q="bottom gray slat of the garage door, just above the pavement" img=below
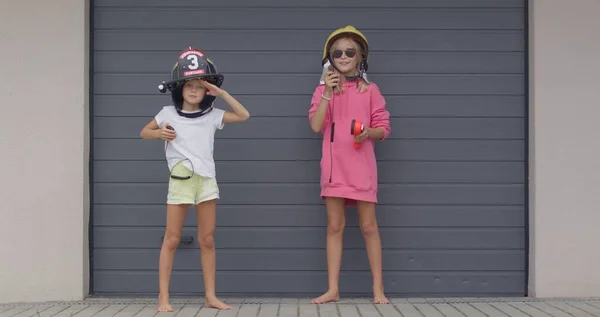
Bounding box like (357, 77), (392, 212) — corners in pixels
(93, 271), (525, 297)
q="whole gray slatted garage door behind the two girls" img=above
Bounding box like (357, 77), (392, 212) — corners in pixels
(92, 0), (526, 296)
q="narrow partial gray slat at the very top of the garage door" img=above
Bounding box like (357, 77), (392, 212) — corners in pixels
(94, 0), (523, 9)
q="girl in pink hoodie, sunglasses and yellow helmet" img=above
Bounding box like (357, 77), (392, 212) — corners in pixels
(309, 26), (391, 304)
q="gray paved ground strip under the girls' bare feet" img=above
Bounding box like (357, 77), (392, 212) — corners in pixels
(0, 298), (600, 317)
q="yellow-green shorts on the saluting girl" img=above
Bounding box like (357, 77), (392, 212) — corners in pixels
(167, 164), (219, 205)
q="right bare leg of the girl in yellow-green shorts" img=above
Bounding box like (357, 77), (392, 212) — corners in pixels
(196, 199), (231, 310)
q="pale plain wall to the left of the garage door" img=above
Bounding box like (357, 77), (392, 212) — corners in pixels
(0, 0), (89, 302)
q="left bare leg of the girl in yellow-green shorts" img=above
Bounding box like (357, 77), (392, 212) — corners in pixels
(158, 205), (190, 312)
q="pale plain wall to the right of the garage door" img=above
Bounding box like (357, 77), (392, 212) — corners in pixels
(530, 0), (600, 297)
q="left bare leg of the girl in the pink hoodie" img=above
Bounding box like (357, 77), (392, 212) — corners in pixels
(312, 197), (346, 304)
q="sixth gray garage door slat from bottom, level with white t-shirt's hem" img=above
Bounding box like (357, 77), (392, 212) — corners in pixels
(94, 161), (525, 184)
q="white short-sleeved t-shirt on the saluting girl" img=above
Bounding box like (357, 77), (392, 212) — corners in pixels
(155, 106), (225, 177)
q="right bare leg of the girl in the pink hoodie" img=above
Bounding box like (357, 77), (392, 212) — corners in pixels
(358, 201), (389, 304)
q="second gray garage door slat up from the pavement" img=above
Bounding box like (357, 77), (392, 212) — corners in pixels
(94, 248), (525, 272)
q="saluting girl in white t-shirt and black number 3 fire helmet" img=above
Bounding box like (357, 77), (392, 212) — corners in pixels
(141, 48), (250, 312)
